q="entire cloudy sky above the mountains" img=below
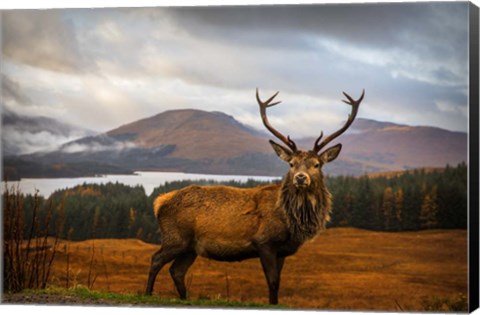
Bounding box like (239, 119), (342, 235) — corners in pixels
(1, 2), (469, 151)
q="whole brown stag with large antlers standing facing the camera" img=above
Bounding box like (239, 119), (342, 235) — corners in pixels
(145, 88), (365, 304)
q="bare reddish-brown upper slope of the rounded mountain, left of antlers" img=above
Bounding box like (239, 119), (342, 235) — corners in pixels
(107, 109), (271, 160)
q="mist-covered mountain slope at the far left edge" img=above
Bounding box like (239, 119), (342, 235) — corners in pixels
(2, 108), (95, 156)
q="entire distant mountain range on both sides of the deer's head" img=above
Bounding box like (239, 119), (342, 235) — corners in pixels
(4, 109), (467, 179)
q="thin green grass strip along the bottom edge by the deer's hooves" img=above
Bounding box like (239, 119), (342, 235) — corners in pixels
(19, 286), (288, 309)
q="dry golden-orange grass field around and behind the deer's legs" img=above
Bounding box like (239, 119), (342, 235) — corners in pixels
(47, 228), (468, 311)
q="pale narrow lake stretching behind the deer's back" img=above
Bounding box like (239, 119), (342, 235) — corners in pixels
(2, 172), (279, 197)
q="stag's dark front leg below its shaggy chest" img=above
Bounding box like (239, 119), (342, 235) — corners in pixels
(259, 248), (283, 304)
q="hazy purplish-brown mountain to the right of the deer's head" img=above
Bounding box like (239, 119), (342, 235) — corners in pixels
(302, 118), (468, 173)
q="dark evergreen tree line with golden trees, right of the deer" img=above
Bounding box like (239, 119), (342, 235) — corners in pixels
(328, 163), (468, 231)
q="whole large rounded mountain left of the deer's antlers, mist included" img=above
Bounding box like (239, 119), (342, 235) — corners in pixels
(53, 109), (281, 175)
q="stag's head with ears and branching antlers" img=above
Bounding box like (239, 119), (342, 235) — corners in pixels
(256, 89), (365, 190)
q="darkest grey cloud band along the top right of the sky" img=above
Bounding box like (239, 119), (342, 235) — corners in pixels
(169, 3), (468, 78)
